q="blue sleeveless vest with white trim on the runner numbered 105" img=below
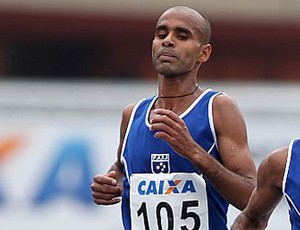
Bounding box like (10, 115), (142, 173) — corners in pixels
(122, 89), (228, 230)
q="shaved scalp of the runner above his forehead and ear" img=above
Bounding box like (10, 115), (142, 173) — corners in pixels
(157, 6), (211, 44)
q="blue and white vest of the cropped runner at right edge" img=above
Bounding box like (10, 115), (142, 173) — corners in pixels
(282, 139), (300, 230)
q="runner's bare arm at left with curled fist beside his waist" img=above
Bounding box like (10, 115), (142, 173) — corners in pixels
(91, 105), (134, 205)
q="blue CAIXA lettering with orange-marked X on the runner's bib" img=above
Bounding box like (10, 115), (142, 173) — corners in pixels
(138, 180), (196, 196)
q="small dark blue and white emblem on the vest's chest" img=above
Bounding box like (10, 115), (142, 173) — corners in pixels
(151, 153), (170, 173)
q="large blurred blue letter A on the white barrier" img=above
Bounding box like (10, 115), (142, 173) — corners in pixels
(34, 138), (93, 205)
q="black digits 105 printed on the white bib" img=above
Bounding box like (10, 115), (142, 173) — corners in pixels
(137, 200), (201, 230)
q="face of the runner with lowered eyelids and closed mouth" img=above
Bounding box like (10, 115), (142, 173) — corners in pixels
(152, 11), (202, 77)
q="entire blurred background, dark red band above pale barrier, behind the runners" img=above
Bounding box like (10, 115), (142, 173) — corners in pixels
(0, 0), (300, 230)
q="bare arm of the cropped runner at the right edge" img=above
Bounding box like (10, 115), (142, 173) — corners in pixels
(231, 148), (288, 230)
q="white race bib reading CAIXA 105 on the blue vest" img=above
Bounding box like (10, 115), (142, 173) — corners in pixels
(130, 173), (209, 230)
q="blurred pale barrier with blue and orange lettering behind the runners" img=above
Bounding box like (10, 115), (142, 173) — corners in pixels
(0, 81), (300, 230)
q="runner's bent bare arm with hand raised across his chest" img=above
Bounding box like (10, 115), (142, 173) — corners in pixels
(151, 95), (256, 209)
